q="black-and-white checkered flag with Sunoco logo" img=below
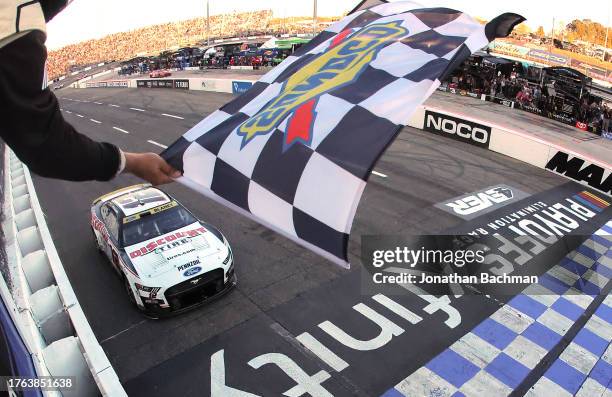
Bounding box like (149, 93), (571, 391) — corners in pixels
(162, 1), (523, 267)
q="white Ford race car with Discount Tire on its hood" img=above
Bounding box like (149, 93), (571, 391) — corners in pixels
(91, 184), (236, 318)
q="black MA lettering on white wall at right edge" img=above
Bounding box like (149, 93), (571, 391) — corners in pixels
(546, 151), (612, 195)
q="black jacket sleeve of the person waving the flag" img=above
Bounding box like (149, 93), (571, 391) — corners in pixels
(0, 31), (120, 181)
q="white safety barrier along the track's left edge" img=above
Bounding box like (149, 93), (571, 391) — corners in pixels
(0, 147), (127, 397)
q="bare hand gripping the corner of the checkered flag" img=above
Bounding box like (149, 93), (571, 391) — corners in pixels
(124, 152), (181, 186)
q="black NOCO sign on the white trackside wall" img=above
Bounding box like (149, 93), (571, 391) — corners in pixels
(424, 110), (491, 149)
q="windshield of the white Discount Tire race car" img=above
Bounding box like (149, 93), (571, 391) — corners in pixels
(122, 205), (197, 247)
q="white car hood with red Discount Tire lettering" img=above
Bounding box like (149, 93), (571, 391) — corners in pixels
(125, 222), (229, 280)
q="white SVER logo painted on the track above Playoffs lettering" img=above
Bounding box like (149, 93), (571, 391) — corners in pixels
(436, 185), (529, 219)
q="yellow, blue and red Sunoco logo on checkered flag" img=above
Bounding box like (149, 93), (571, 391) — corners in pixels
(237, 21), (408, 150)
